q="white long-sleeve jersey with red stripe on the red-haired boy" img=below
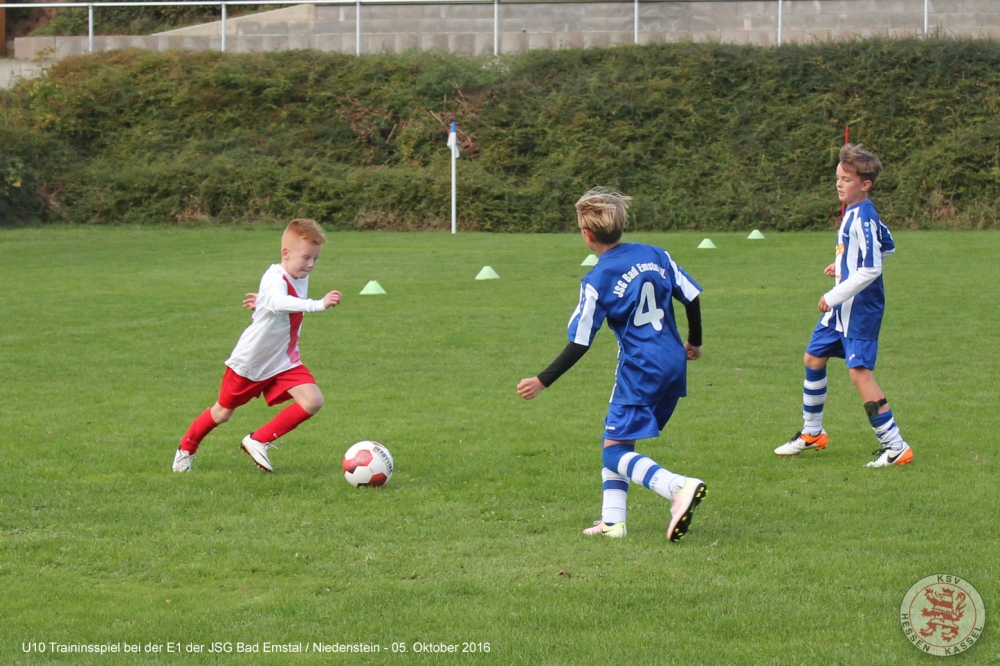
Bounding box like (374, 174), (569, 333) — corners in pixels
(226, 264), (326, 382)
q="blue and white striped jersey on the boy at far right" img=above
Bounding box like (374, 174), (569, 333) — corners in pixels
(820, 199), (896, 340)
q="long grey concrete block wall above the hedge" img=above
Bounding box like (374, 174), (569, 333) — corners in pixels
(9, 0), (1000, 74)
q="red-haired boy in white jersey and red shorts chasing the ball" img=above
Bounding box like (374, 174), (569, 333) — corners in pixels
(173, 220), (340, 472)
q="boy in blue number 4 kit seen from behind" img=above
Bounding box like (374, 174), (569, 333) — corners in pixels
(517, 189), (706, 541)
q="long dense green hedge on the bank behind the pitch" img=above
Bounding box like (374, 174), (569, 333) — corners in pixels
(0, 39), (1000, 231)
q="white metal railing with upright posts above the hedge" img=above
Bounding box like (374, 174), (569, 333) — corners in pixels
(0, 0), (930, 55)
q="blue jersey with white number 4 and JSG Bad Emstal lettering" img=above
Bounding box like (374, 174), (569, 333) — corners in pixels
(569, 243), (701, 405)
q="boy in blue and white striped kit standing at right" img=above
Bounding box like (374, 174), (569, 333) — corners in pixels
(774, 144), (913, 467)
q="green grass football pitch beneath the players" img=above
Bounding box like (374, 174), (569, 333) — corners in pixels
(0, 228), (1000, 664)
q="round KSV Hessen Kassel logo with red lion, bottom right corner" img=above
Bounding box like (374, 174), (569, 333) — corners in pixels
(899, 574), (986, 657)
